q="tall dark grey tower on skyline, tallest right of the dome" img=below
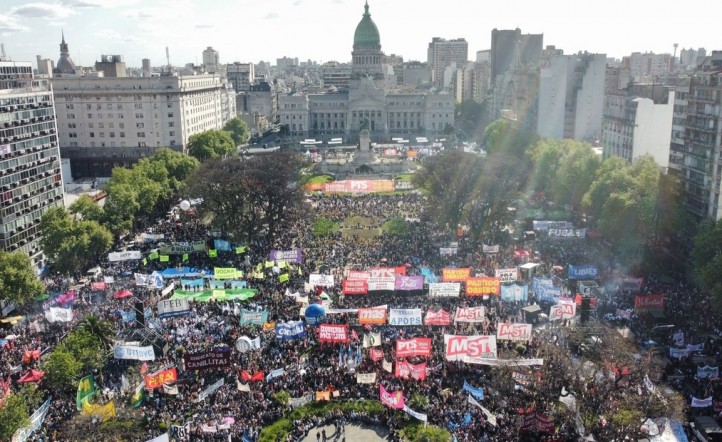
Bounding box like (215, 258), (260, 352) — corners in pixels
(491, 28), (544, 85)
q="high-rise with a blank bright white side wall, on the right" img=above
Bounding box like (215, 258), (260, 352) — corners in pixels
(602, 84), (675, 167)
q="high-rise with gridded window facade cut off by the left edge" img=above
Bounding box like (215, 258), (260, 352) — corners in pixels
(0, 61), (63, 267)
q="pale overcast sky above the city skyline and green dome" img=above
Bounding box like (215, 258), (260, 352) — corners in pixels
(0, 0), (722, 66)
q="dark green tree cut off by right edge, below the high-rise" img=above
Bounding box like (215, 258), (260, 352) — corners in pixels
(691, 220), (722, 310)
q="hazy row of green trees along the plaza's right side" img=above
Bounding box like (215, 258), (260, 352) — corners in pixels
(414, 120), (687, 263)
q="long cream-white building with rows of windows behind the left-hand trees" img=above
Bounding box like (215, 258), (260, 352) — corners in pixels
(51, 74), (236, 177)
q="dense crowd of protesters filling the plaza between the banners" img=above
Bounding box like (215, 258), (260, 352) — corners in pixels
(0, 195), (722, 442)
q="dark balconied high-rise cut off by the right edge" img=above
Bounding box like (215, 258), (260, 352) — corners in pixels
(679, 51), (722, 220)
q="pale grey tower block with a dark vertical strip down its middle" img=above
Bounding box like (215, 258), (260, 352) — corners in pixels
(537, 53), (606, 140)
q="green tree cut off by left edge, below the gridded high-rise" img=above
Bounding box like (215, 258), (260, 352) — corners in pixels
(0, 250), (45, 305)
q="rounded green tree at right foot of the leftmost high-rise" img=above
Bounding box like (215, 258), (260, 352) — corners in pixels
(40, 207), (113, 274)
